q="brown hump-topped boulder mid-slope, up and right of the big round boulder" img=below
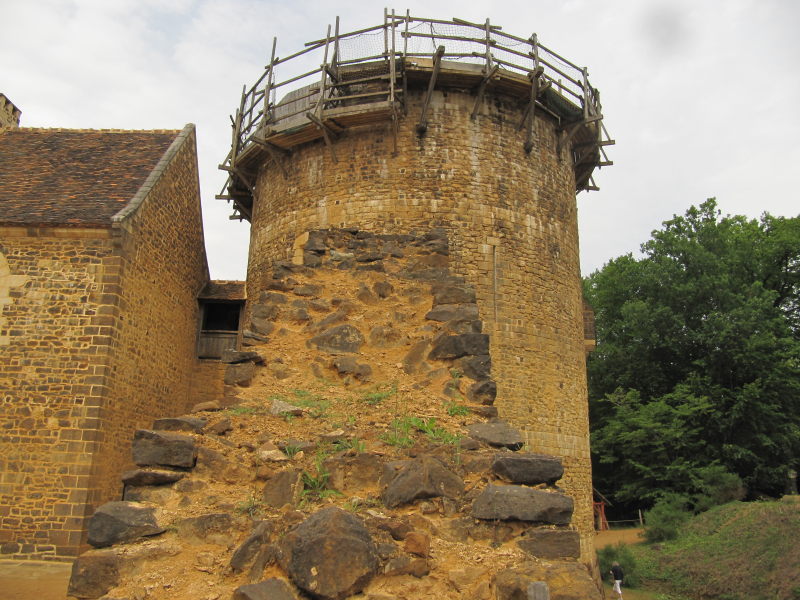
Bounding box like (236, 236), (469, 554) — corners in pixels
(382, 456), (464, 508)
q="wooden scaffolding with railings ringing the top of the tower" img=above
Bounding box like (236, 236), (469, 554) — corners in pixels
(217, 10), (614, 220)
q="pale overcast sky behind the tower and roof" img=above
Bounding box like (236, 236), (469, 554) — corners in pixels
(0, 0), (800, 279)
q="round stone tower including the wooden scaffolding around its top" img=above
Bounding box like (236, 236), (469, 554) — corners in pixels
(221, 14), (612, 558)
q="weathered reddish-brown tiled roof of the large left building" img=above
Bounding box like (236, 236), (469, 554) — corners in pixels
(0, 128), (180, 227)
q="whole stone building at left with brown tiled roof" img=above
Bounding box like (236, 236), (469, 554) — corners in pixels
(0, 119), (212, 558)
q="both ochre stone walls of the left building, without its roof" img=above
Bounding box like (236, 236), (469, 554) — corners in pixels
(0, 127), (208, 559)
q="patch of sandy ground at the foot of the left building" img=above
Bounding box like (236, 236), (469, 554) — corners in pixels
(0, 561), (72, 600)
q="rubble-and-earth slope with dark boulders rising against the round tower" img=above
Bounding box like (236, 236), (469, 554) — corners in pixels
(70, 230), (599, 600)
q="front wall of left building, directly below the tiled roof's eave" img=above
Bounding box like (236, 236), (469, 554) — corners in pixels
(0, 228), (116, 559)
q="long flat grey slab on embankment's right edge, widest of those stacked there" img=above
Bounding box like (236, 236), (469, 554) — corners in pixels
(472, 484), (573, 525)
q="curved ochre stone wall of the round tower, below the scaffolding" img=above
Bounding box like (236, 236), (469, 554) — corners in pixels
(248, 91), (593, 560)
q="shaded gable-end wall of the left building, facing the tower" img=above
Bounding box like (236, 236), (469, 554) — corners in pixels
(87, 127), (209, 536)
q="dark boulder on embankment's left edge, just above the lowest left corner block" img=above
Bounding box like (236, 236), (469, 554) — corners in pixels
(87, 501), (166, 548)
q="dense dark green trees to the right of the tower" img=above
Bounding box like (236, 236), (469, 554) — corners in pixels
(584, 199), (800, 503)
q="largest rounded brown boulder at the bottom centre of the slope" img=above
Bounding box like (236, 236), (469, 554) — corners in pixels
(284, 506), (378, 600)
